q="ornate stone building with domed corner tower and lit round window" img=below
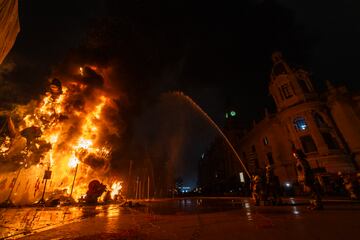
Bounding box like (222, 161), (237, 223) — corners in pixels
(199, 52), (360, 193)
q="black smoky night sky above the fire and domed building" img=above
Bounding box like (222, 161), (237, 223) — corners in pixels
(0, 0), (360, 188)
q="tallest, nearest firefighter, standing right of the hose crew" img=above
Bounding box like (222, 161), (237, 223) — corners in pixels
(293, 149), (323, 210)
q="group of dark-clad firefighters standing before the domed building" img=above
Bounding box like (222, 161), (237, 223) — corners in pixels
(251, 149), (360, 210)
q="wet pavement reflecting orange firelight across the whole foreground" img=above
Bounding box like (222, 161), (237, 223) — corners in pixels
(0, 198), (360, 240)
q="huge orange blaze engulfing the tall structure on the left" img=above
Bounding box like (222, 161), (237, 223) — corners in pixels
(0, 68), (121, 204)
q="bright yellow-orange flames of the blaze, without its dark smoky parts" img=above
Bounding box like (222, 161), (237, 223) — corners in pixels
(0, 64), (122, 202)
